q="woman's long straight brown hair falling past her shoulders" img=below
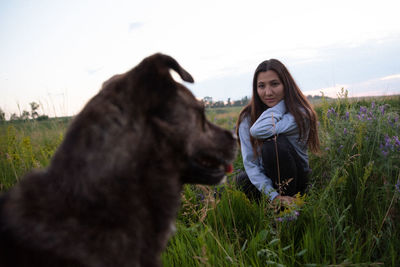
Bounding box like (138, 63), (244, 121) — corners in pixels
(236, 59), (319, 155)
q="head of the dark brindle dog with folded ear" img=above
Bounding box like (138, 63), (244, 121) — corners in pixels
(103, 54), (236, 184)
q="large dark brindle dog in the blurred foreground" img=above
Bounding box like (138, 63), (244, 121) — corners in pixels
(0, 53), (236, 267)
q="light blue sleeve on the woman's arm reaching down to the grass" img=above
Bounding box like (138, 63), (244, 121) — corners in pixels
(239, 117), (279, 201)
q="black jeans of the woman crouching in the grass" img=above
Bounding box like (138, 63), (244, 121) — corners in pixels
(236, 135), (309, 200)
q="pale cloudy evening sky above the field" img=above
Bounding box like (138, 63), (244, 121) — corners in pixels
(0, 0), (400, 117)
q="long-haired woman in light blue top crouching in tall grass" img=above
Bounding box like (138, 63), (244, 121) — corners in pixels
(236, 59), (319, 204)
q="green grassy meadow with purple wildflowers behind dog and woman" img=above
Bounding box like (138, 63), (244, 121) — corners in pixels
(0, 92), (400, 267)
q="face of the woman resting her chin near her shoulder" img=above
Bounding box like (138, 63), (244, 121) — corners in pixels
(257, 70), (285, 108)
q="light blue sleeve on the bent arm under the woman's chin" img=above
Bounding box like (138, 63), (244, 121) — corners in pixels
(250, 100), (298, 139)
